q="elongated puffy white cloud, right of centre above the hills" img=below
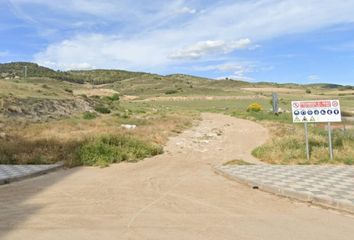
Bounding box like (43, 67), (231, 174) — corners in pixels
(170, 38), (251, 59)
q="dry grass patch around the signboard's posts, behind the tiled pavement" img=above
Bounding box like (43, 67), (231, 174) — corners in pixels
(252, 123), (354, 165)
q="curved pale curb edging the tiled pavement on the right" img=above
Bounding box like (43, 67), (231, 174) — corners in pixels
(213, 166), (354, 214)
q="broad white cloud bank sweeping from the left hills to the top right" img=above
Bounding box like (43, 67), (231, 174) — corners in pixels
(18, 0), (354, 71)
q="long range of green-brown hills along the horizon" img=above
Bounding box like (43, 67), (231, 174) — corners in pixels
(0, 62), (353, 90)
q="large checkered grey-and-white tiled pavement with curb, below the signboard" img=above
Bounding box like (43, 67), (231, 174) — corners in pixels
(217, 165), (354, 213)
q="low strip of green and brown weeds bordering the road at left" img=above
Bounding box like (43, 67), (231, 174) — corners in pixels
(0, 135), (162, 167)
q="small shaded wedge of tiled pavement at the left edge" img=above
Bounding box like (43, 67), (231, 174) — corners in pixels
(0, 163), (63, 185)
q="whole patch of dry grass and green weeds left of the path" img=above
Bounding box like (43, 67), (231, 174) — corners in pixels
(0, 113), (195, 166)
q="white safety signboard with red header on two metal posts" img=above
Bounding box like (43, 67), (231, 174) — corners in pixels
(291, 100), (342, 160)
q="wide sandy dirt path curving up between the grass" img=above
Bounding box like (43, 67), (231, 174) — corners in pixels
(0, 114), (354, 240)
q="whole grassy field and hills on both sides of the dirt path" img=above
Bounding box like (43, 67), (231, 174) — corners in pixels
(0, 62), (354, 166)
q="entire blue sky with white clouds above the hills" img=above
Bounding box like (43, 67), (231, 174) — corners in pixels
(0, 0), (354, 85)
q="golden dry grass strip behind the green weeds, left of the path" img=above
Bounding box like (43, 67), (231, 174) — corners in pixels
(11, 111), (195, 144)
